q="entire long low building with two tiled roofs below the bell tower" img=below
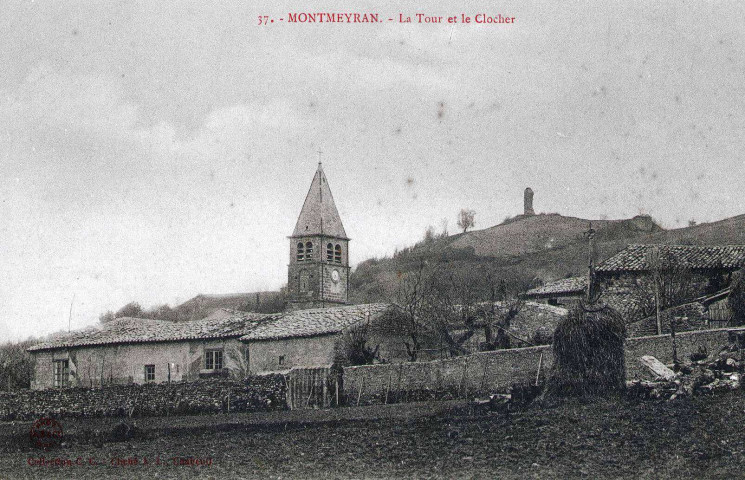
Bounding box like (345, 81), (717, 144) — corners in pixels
(29, 304), (407, 390)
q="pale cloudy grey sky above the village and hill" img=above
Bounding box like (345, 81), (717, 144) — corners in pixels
(0, 0), (745, 339)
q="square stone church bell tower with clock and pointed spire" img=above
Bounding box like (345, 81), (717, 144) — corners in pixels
(287, 162), (349, 310)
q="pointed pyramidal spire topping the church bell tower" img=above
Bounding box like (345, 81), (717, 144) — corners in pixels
(292, 161), (347, 239)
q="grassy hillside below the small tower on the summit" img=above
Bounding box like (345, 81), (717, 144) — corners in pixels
(351, 214), (745, 302)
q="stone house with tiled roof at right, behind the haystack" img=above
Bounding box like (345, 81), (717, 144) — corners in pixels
(595, 245), (745, 323)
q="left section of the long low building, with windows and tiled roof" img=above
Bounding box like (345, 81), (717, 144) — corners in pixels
(28, 310), (272, 390)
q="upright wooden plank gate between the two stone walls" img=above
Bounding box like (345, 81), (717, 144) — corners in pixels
(285, 366), (341, 410)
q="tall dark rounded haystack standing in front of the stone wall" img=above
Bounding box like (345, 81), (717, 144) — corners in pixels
(545, 304), (626, 396)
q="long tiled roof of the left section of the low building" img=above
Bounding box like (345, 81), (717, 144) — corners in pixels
(28, 309), (272, 351)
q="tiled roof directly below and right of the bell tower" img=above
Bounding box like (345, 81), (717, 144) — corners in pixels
(241, 303), (392, 341)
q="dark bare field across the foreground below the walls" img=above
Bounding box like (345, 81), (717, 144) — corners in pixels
(0, 392), (745, 479)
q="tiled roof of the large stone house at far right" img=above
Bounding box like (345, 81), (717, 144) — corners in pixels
(596, 245), (745, 273)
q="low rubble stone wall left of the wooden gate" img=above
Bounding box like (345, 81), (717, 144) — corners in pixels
(0, 375), (286, 420)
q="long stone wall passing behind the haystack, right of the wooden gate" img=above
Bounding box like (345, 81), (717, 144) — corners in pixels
(344, 329), (745, 404)
